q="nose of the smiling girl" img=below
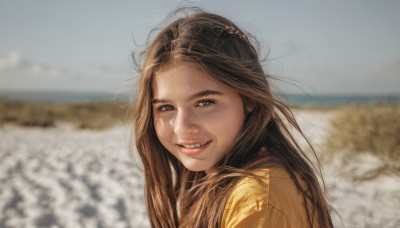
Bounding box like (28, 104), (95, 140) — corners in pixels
(172, 110), (199, 136)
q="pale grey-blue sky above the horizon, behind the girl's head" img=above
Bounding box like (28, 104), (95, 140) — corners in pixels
(0, 0), (400, 95)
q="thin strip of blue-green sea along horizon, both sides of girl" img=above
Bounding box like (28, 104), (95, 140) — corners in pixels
(0, 91), (400, 106)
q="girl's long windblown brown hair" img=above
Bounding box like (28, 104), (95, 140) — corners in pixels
(134, 9), (332, 227)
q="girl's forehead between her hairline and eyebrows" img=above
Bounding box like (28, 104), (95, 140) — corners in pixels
(153, 63), (228, 98)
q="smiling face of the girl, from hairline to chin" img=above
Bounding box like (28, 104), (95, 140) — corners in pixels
(153, 63), (245, 172)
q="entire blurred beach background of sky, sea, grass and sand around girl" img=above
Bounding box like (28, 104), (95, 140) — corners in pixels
(0, 0), (400, 227)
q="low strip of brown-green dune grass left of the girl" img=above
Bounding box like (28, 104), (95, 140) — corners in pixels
(0, 100), (133, 130)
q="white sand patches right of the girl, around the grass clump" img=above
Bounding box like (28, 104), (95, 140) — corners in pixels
(297, 111), (400, 228)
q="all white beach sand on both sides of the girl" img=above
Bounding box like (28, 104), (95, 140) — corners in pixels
(0, 111), (400, 228)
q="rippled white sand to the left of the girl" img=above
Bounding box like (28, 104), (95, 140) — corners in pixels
(0, 124), (148, 227)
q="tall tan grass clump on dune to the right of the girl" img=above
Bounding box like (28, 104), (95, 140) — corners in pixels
(326, 103), (400, 174)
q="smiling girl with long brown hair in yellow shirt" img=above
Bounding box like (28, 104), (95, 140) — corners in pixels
(134, 10), (332, 227)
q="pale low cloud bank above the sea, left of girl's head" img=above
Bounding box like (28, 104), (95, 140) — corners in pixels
(0, 52), (128, 92)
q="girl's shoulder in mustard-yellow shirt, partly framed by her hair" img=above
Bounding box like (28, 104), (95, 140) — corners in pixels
(222, 167), (306, 227)
